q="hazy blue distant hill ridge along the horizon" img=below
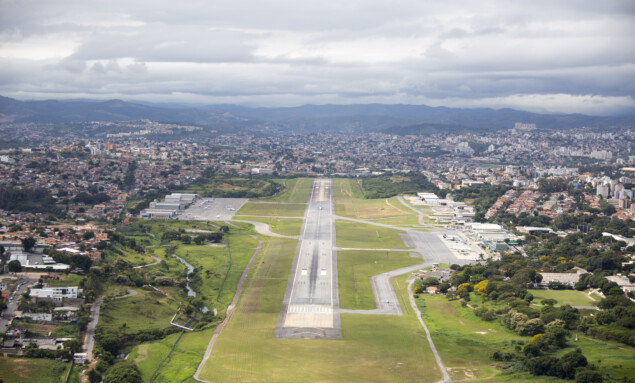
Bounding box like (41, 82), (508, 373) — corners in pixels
(0, 96), (635, 134)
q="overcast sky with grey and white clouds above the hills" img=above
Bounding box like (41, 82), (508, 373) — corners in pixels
(0, 0), (635, 115)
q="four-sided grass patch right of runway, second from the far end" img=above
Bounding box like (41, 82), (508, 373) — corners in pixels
(335, 220), (408, 249)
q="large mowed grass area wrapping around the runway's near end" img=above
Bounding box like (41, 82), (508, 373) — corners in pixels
(200, 238), (441, 383)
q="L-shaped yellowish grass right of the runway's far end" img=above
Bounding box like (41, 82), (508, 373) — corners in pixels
(333, 178), (416, 219)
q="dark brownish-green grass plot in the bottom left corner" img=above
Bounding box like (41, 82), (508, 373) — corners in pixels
(0, 356), (69, 383)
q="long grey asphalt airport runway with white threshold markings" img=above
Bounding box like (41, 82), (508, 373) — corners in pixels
(275, 178), (341, 339)
